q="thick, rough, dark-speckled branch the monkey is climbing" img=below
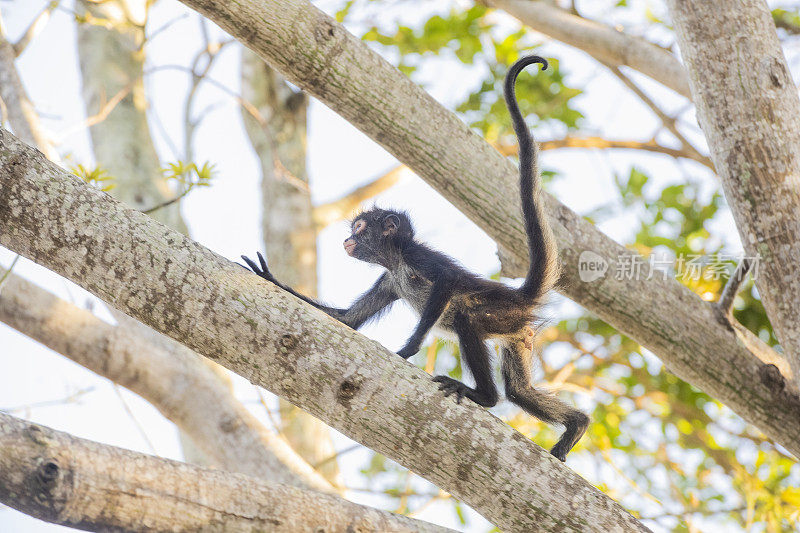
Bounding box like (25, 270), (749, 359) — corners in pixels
(0, 130), (646, 531)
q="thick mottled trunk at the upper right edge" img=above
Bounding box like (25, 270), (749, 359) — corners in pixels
(668, 0), (800, 379)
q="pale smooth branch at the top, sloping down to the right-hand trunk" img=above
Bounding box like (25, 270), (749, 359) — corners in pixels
(481, 0), (692, 98)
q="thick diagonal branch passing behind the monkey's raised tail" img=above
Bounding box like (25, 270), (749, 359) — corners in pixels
(173, 0), (800, 456)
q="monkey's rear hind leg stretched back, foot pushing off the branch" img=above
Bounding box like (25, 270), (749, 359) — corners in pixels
(502, 342), (589, 462)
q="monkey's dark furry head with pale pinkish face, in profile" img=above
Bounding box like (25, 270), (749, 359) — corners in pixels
(344, 207), (414, 266)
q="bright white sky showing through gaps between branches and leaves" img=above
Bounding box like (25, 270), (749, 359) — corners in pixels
(0, 0), (788, 531)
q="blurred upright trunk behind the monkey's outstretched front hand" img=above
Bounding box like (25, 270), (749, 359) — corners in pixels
(242, 48), (339, 484)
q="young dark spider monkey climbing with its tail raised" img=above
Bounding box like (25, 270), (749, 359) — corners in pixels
(247, 56), (589, 461)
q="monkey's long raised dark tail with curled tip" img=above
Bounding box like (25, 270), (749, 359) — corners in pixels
(505, 56), (558, 300)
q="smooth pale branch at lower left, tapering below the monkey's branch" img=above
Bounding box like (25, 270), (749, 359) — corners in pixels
(0, 274), (334, 492)
